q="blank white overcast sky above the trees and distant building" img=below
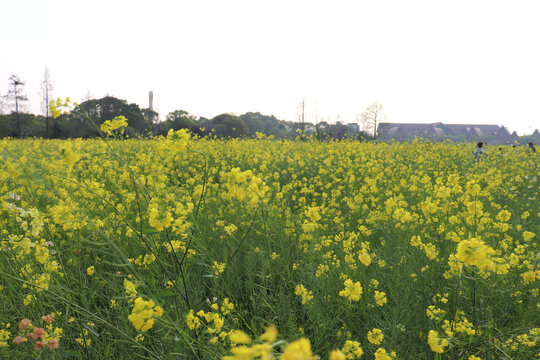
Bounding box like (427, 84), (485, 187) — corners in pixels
(0, 0), (540, 134)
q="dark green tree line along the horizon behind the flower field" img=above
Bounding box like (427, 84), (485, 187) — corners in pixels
(0, 69), (376, 140)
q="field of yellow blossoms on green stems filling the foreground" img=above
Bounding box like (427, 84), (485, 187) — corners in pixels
(0, 129), (540, 360)
